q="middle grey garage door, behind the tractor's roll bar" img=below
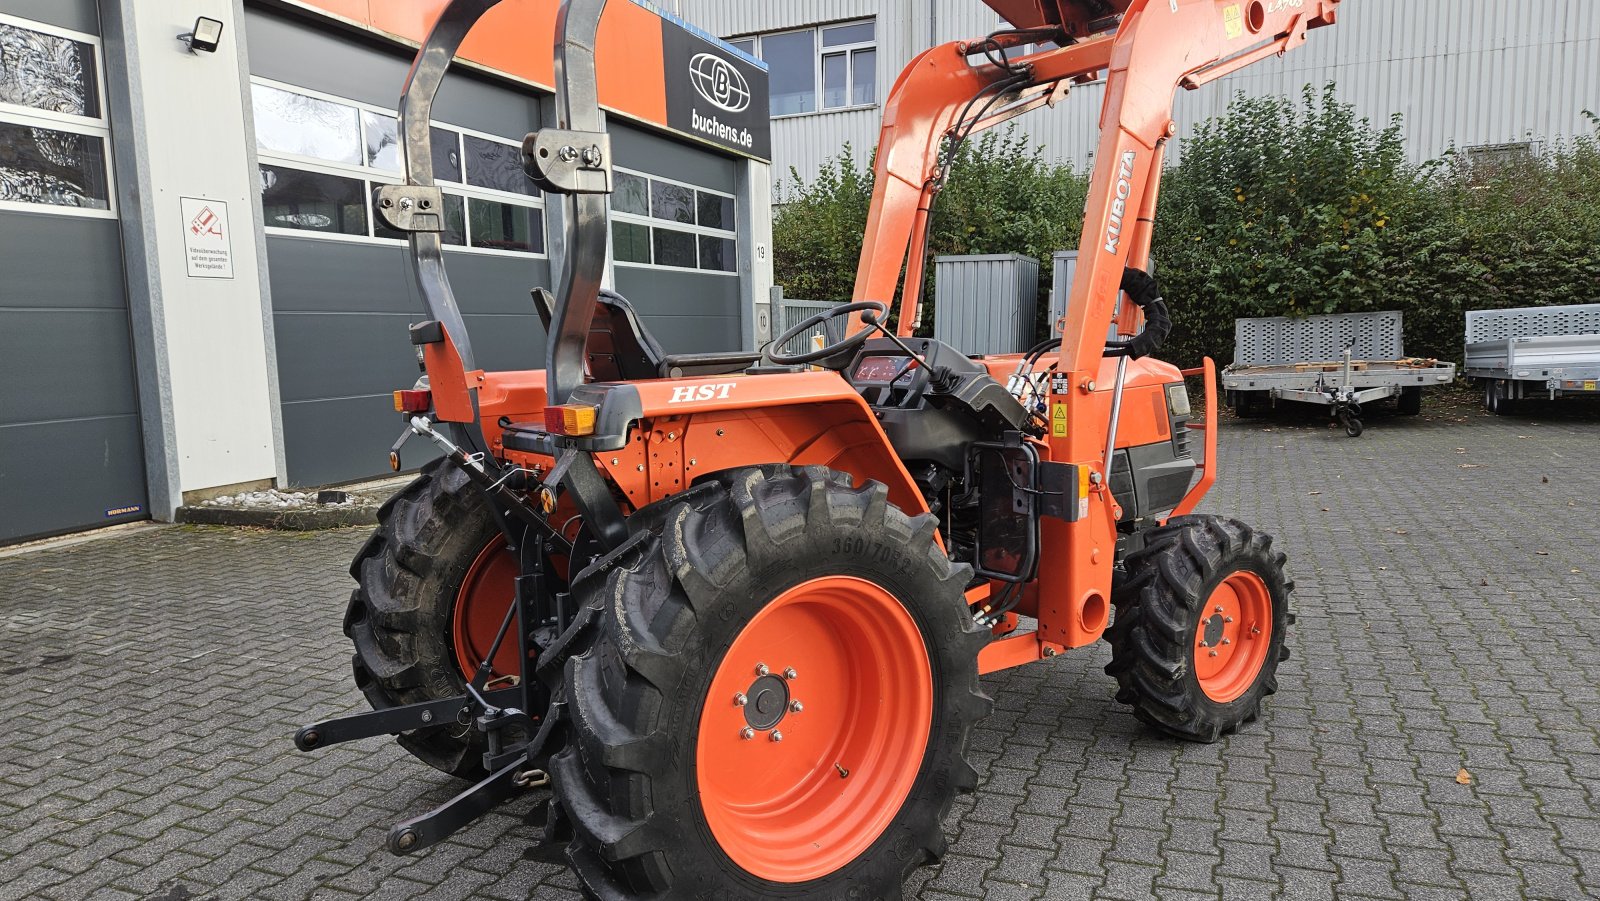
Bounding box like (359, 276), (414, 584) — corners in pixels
(246, 11), (550, 485)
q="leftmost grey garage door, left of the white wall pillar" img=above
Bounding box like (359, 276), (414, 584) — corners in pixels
(0, 0), (147, 543)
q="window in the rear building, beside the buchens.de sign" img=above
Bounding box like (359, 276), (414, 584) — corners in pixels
(728, 19), (878, 115)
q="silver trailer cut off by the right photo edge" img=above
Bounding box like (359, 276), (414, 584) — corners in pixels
(1462, 304), (1600, 414)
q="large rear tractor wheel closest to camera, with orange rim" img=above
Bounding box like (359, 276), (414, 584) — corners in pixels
(550, 467), (990, 898)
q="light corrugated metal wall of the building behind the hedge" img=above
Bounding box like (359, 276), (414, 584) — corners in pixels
(672, 0), (1600, 184)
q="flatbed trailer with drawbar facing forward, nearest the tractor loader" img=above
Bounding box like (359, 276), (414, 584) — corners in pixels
(1222, 310), (1456, 437)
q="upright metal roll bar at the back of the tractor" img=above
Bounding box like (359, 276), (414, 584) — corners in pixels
(378, 0), (611, 408)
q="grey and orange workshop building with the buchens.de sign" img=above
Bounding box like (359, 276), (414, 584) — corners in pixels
(0, 0), (771, 543)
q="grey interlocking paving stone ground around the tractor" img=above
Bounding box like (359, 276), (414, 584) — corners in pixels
(0, 396), (1600, 901)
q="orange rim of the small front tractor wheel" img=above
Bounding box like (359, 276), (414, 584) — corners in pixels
(1195, 570), (1272, 704)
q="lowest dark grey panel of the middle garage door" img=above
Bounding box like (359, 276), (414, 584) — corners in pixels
(283, 392), (438, 485)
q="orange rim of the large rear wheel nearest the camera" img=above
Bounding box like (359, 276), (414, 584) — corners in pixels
(694, 576), (933, 882)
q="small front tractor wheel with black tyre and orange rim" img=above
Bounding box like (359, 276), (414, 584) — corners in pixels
(1106, 515), (1294, 743)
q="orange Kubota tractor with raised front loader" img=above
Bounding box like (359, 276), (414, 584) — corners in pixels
(296, 0), (1339, 898)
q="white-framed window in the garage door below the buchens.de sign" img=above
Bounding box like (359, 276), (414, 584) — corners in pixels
(611, 170), (739, 272)
